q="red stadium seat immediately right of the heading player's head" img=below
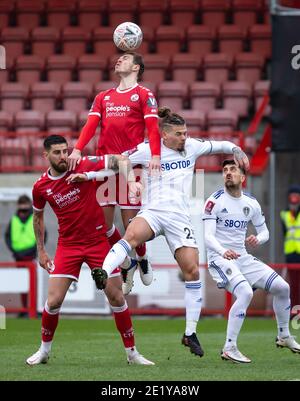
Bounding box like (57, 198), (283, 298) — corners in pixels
(139, 54), (170, 84)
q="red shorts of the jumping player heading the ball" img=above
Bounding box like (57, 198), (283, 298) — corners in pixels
(96, 166), (141, 210)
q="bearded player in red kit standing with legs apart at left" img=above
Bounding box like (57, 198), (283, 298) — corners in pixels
(26, 135), (154, 365)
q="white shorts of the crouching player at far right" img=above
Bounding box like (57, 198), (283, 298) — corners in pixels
(208, 253), (278, 292)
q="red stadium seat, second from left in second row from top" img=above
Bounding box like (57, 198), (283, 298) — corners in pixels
(31, 27), (60, 57)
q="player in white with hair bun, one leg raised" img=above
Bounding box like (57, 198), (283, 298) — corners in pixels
(68, 109), (249, 357)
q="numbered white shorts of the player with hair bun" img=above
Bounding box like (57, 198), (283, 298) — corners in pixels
(136, 210), (198, 255)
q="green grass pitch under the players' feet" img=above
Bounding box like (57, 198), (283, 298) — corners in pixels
(0, 318), (300, 382)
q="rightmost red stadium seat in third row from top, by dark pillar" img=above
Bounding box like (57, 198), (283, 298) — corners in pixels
(235, 53), (264, 85)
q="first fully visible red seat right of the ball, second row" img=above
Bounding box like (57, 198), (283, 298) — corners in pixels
(156, 25), (184, 56)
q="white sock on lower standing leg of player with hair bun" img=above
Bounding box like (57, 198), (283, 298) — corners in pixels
(184, 280), (202, 336)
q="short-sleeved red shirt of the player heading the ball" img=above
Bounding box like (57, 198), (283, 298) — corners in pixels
(89, 84), (158, 155)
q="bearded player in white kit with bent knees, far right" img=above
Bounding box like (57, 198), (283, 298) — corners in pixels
(203, 160), (300, 363)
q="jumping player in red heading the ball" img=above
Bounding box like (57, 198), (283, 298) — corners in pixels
(69, 52), (160, 285)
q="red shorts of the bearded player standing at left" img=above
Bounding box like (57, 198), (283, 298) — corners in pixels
(50, 237), (120, 281)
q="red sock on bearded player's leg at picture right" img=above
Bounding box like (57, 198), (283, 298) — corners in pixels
(112, 303), (135, 348)
